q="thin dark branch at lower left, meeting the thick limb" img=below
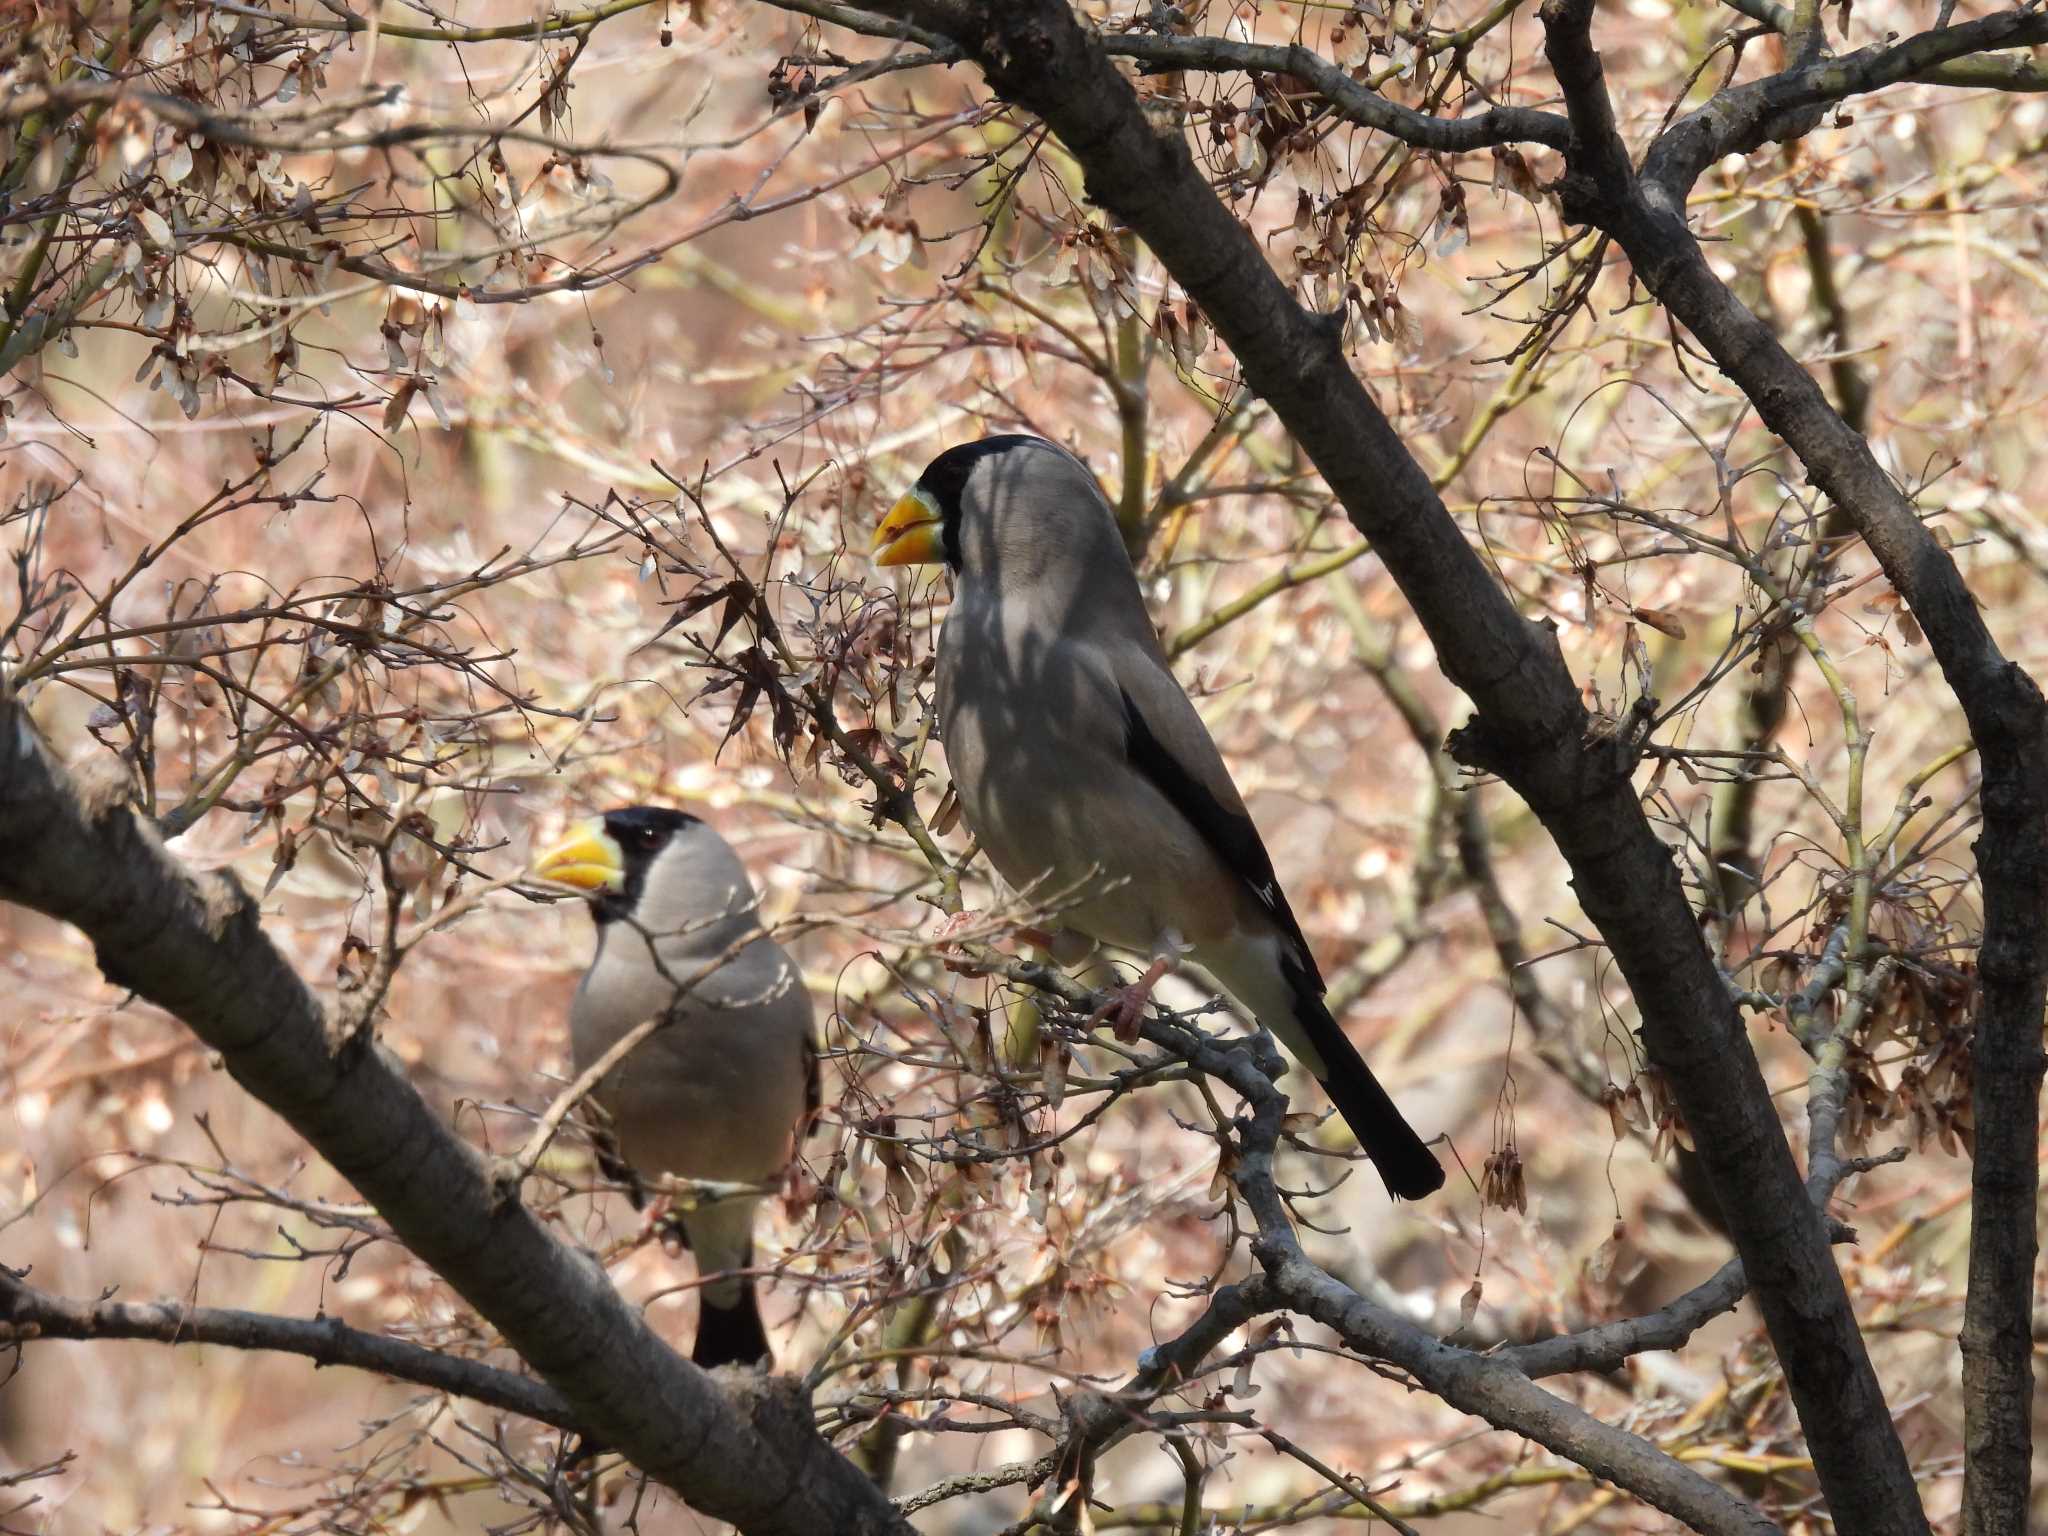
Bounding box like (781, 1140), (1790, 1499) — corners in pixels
(0, 1266), (584, 1430)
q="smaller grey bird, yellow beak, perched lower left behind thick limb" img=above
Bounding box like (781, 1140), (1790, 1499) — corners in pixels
(532, 805), (817, 1370)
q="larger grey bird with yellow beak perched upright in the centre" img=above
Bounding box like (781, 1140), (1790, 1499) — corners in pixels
(870, 434), (1444, 1200)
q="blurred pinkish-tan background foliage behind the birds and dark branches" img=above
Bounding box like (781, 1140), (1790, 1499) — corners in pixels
(0, 0), (2048, 1534)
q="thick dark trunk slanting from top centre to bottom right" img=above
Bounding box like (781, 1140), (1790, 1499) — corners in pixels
(864, 0), (1927, 1536)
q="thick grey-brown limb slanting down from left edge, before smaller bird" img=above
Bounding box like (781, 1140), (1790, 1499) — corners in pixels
(0, 690), (909, 1536)
